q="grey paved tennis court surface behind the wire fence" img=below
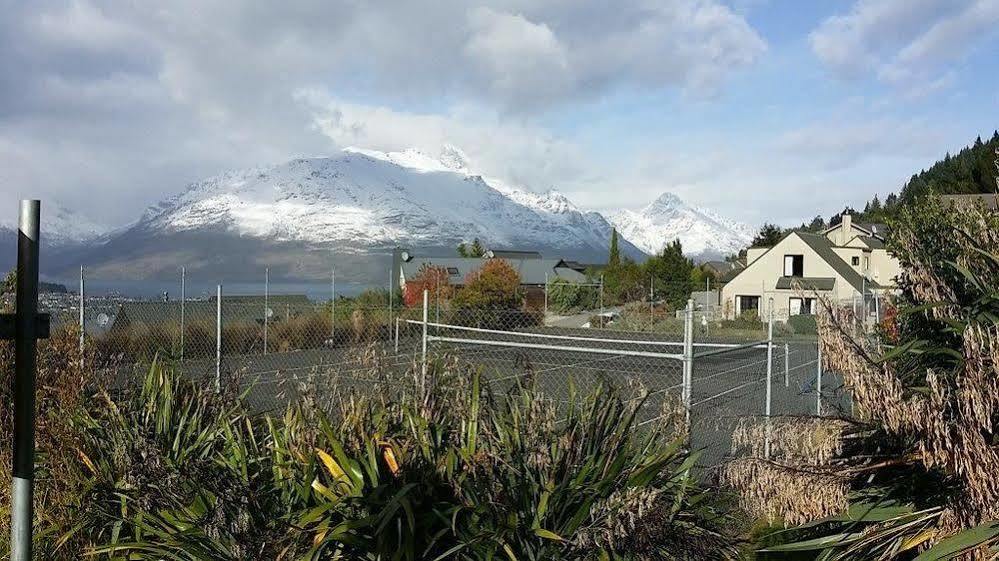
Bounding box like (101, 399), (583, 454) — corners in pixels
(103, 327), (845, 466)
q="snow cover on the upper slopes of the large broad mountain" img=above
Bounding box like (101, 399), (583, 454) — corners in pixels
(129, 146), (640, 255)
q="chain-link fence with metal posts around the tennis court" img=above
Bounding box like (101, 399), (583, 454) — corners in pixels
(41, 274), (848, 465)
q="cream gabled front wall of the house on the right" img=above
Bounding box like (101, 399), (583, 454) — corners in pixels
(721, 235), (854, 319)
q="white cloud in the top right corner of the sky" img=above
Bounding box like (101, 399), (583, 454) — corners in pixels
(809, 0), (999, 92)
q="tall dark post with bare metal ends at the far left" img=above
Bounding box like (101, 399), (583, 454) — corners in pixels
(10, 200), (41, 561)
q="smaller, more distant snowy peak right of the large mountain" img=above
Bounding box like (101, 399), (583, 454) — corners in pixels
(610, 193), (754, 259)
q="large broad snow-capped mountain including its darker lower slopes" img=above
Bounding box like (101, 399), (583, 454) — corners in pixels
(76, 146), (643, 280)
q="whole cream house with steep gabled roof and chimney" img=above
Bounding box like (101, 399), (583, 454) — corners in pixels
(721, 215), (899, 319)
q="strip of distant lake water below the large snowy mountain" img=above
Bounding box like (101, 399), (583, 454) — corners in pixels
(42, 278), (384, 301)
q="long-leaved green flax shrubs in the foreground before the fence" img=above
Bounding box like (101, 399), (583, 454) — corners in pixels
(7, 340), (734, 560)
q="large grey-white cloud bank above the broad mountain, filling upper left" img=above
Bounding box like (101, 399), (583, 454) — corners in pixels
(0, 0), (766, 223)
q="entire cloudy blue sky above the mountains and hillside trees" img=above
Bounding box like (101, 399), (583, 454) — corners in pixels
(0, 0), (999, 229)
